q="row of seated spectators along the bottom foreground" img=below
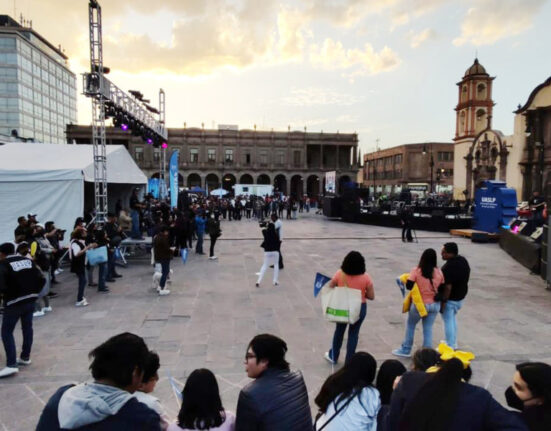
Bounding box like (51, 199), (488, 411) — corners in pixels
(28, 333), (551, 431)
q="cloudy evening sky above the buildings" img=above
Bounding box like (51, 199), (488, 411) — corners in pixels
(4, 0), (551, 153)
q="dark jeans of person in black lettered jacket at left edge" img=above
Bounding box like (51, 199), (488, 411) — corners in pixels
(2, 301), (34, 368)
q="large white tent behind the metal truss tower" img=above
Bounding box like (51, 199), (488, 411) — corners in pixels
(0, 142), (147, 242)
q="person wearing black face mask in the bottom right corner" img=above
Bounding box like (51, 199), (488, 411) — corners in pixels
(505, 362), (551, 431)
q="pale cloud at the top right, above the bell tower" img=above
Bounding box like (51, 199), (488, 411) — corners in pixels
(453, 0), (545, 46)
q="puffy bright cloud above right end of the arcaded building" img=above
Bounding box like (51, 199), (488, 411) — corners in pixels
(310, 38), (401, 76)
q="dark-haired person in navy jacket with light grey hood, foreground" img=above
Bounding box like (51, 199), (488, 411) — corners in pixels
(36, 332), (161, 431)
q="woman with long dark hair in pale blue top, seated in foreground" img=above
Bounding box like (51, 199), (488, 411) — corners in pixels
(314, 352), (381, 431)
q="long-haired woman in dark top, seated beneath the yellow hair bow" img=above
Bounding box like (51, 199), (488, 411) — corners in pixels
(389, 358), (526, 431)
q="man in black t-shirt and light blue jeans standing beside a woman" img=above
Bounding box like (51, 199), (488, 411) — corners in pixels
(440, 242), (471, 349)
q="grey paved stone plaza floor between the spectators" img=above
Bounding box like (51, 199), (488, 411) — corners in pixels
(0, 212), (551, 431)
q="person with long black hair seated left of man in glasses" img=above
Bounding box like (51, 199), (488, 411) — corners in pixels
(168, 368), (235, 431)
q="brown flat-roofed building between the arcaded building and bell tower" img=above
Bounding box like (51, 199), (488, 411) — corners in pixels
(363, 142), (454, 194)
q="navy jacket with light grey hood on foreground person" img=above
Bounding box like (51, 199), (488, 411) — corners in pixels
(36, 383), (161, 431)
